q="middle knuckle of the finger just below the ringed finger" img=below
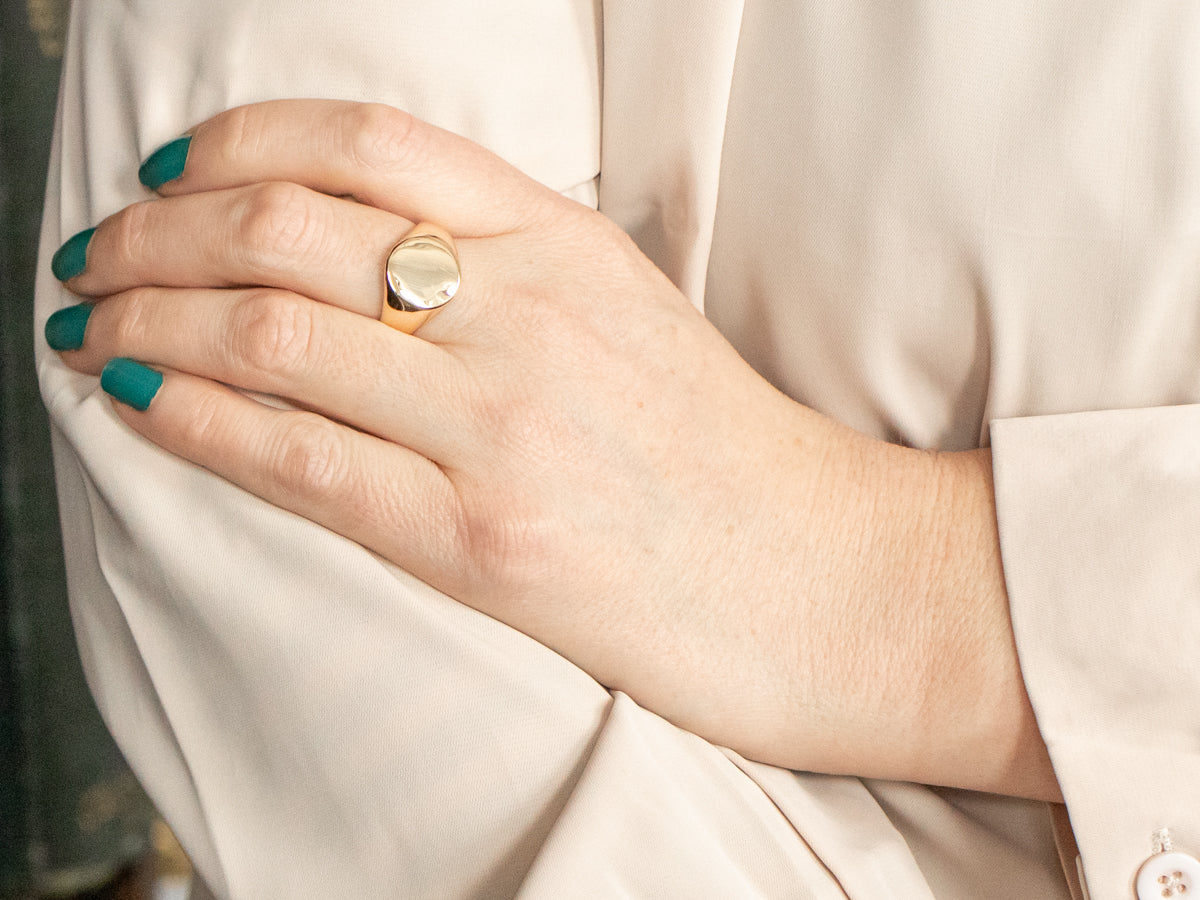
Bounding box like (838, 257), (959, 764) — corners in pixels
(229, 288), (314, 377)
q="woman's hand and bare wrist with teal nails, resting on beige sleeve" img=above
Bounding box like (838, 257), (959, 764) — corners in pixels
(50, 101), (1056, 796)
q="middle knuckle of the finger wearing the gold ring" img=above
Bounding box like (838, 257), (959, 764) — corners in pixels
(234, 181), (319, 271)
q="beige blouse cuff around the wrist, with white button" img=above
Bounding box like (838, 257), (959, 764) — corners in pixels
(991, 404), (1200, 900)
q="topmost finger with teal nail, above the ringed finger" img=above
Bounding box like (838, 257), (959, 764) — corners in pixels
(143, 100), (557, 238)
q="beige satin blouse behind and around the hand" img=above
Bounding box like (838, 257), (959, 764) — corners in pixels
(30, 0), (1200, 900)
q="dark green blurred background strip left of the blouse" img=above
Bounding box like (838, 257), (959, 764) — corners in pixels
(0, 0), (152, 898)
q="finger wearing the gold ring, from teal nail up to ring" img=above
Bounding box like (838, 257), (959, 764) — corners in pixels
(63, 181), (410, 318)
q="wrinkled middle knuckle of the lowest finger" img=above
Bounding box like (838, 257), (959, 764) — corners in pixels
(268, 413), (349, 498)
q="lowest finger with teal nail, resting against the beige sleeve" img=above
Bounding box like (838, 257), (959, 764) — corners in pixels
(102, 360), (457, 576)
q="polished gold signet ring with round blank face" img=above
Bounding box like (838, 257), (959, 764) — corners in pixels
(379, 222), (462, 335)
